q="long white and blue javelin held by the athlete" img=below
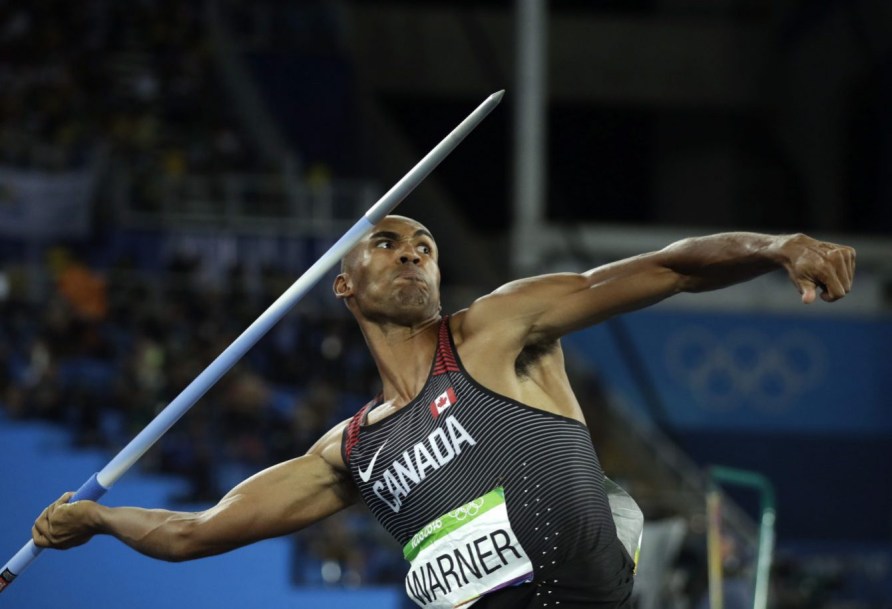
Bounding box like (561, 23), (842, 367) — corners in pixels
(0, 90), (505, 591)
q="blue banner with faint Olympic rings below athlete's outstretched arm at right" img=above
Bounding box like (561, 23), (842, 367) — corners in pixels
(564, 309), (892, 434)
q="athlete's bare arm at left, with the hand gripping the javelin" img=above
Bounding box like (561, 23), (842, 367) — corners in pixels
(32, 421), (357, 561)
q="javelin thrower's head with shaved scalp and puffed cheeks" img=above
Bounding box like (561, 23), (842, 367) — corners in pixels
(334, 216), (440, 324)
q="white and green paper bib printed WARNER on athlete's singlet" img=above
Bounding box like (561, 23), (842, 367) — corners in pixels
(403, 487), (533, 609)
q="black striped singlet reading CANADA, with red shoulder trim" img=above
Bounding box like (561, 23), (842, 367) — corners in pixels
(342, 318), (633, 609)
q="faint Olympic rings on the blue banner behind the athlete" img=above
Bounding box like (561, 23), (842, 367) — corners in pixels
(665, 326), (828, 412)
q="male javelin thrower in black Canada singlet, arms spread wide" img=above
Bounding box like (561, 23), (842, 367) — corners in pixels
(33, 216), (855, 609)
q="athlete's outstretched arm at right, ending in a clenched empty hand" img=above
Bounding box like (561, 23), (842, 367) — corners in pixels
(466, 232), (855, 344)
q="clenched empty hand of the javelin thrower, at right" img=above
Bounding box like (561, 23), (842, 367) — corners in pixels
(781, 234), (855, 304)
